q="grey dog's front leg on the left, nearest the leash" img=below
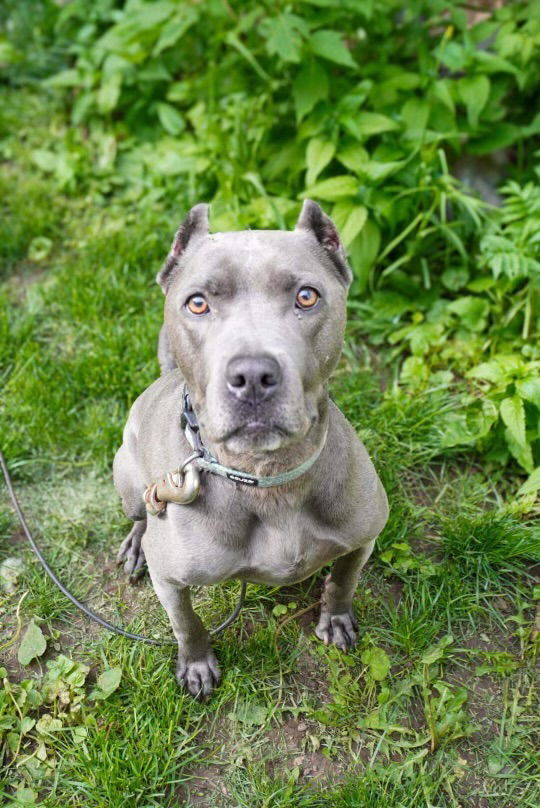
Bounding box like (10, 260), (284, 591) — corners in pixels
(152, 577), (221, 699)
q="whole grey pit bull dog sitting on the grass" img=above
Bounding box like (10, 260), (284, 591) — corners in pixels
(114, 200), (388, 697)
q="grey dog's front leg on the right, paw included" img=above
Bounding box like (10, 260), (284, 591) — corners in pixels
(315, 541), (375, 652)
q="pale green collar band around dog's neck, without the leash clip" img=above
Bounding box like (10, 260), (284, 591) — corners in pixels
(180, 388), (328, 488)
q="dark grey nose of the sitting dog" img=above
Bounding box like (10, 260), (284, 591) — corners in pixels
(225, 356), (281, 404)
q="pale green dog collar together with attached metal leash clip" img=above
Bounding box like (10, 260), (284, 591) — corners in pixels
(144, 389), (328, 515)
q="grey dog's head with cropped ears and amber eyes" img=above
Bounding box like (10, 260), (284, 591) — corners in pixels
(157, 200), (352, 453)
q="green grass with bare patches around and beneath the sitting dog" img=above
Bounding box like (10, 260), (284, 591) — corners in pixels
(0, 91), (540, 808)
